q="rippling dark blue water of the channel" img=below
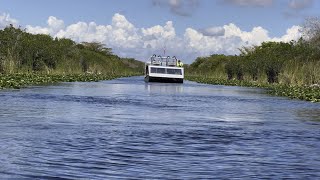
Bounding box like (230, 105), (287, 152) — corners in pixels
(0, 77), (320, 179)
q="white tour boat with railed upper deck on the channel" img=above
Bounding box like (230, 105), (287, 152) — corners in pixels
(144, 54), (184, 83)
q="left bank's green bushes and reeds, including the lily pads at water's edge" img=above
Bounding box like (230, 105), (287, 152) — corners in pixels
(0, 25), (144, 89)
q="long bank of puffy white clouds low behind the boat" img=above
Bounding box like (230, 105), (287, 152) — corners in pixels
(23, 13), (301, 63)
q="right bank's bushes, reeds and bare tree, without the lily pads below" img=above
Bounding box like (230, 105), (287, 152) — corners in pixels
(186, 18), (320, 85)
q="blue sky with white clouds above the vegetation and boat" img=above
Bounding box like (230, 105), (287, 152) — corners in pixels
(0, 0), (320, 63)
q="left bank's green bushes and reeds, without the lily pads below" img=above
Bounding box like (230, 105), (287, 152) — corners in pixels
(0, 25), (143, 74)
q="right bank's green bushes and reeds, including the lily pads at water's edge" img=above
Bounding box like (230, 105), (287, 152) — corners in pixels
(185, 18), (320, 102)
